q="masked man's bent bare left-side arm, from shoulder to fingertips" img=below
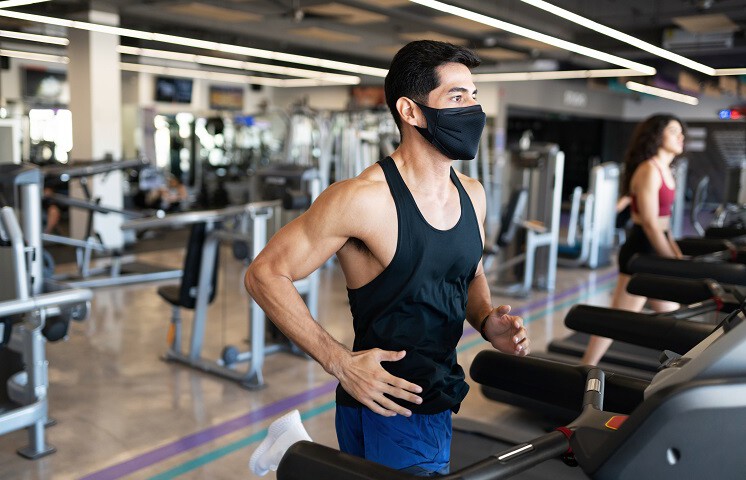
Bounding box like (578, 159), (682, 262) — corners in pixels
(244, 180), (422, 416)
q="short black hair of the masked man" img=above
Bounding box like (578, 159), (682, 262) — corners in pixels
(384, 40), (482, 130)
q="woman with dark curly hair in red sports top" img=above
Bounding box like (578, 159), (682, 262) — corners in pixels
(582, 114), (684, 365)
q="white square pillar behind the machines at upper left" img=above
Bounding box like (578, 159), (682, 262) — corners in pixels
(67, 1), (124, 248)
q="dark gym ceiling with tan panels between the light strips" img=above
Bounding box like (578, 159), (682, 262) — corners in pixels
(0, 0), (746, 83)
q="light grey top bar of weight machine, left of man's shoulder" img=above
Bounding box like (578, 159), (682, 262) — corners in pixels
(122, 200), (282, 230)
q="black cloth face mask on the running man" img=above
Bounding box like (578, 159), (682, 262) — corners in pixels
(414, 102), (487, 160)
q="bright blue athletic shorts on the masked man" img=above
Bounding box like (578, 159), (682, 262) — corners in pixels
(335, 405), (452, 476)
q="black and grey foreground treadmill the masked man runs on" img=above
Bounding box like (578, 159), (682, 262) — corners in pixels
(277, 309), (746, 480)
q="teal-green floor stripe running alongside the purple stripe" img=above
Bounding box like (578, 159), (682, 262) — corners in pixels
(154, 279), (616, 480)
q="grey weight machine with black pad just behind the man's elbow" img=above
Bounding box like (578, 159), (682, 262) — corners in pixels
(122, 169), (320, 390)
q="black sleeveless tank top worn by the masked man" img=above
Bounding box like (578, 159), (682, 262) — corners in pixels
(337, 157), (482, 414)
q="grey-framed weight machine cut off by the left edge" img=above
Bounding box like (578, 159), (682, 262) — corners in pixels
(0, 165), (93, 459)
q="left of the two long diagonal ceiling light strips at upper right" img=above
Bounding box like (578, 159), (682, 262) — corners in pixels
(410, 0), (655, 75)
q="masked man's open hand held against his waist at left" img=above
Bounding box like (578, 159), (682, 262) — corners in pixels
(336, 348), (422, 417)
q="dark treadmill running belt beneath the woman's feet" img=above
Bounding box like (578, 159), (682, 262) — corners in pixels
(547, 333), (661, 372)
